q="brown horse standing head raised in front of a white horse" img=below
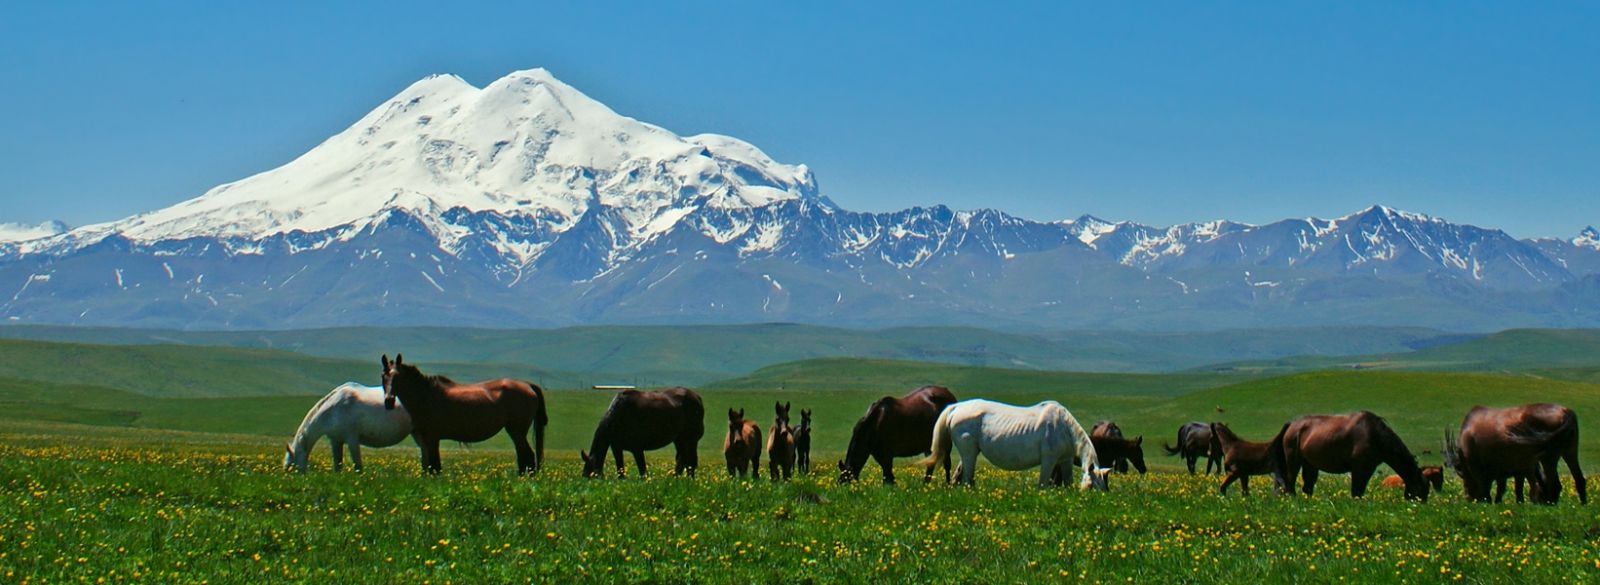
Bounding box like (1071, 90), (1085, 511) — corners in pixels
(382, 353), (550, 473)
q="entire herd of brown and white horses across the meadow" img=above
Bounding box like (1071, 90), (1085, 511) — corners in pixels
(283, 355), (1589, 503)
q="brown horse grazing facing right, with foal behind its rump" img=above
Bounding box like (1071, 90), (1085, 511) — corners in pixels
(1272, 411), (1427, 502)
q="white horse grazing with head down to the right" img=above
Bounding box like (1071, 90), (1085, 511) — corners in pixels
(923, 398), (1110, 489)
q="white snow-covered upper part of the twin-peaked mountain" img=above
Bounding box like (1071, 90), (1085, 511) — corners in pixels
(42, 69), (818, 256)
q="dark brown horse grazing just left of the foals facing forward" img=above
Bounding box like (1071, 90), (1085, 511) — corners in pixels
(578, 388), (706, 478)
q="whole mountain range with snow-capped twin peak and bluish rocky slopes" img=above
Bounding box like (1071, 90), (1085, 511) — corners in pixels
(0, 69), (1600, 329)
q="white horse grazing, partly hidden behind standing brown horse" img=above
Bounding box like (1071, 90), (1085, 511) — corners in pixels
(283, 382), (411, 473)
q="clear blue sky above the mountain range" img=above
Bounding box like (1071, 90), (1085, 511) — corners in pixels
(0, 2), (1600, 237)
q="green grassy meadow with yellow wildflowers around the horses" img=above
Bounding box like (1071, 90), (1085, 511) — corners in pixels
(0, 330), (1600, 583)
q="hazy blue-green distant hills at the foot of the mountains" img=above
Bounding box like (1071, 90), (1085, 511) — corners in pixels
(0, 324), (1456, 385)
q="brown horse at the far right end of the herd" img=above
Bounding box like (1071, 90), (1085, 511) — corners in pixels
(1445, 404), (1589, 503)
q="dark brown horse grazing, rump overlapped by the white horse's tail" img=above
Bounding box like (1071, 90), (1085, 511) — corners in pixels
(838, 385), (955, 484)
